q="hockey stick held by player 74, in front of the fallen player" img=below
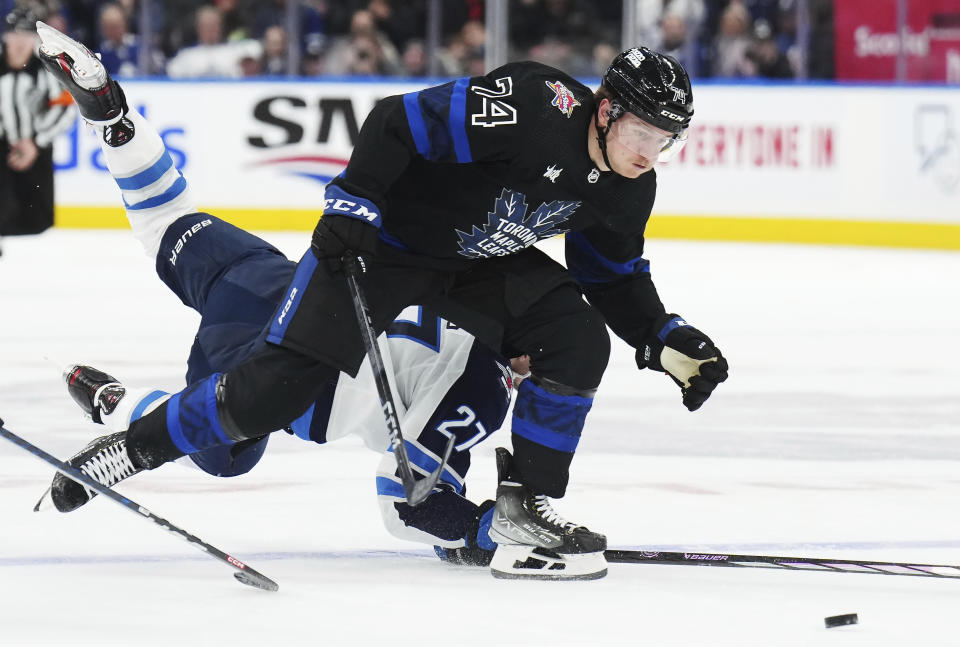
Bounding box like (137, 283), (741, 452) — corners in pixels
(343, 251), (455, 506)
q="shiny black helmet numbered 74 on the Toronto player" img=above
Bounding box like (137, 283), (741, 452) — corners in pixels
(603, 47), (693, 135)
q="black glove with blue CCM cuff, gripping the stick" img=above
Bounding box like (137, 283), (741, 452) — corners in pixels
(311, 184), (380, 272)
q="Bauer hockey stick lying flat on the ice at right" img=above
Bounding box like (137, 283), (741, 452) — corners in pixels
(603, 550), (960, 579)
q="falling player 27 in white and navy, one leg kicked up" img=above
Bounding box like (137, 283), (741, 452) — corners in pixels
(33, 23), (525, 565)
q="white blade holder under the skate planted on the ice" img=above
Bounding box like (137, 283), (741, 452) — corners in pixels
(490, 545), (607, 580)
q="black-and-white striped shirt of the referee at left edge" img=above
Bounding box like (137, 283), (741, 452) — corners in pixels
(0, 44), (76, 148)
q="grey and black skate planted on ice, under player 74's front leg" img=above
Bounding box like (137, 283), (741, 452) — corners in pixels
(489, 447), (607, 580)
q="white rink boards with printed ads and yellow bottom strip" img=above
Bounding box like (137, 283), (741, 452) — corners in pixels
(55, 81), (960, 248)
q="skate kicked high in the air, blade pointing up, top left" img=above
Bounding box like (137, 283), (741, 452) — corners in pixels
(37, 21), (132, 133)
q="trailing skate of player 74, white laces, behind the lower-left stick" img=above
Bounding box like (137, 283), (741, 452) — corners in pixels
(47, 431), (143, 512)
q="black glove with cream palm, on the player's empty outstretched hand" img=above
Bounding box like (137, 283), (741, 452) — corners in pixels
(637, 314), (728, 411)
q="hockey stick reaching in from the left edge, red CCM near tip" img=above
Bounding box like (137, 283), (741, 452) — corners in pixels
(0, 419), (280, 591)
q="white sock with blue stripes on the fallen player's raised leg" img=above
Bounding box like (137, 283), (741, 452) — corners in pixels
(97, 110), (197, 258)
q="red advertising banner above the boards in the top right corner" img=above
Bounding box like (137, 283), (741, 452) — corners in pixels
(834, 0), (960, 83)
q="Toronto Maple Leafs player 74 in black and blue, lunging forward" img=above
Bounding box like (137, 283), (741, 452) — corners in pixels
(39, 24), (727, 579)
